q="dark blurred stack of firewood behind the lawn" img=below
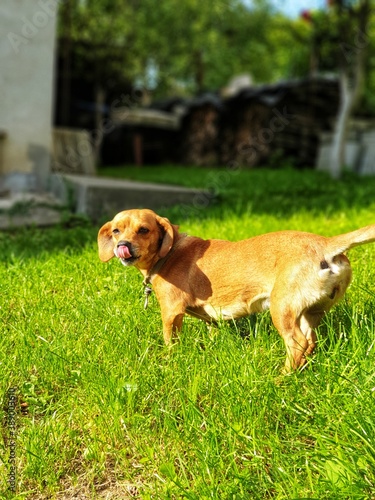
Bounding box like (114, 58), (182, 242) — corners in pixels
(180, 78), (339, 167)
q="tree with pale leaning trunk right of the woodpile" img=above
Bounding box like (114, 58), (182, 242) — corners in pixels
(303, 0), (371, 179)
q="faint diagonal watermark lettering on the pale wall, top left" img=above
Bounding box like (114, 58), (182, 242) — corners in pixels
(7, 0), (65, 54)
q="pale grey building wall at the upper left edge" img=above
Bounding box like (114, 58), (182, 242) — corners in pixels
(0, 0), (58, 191)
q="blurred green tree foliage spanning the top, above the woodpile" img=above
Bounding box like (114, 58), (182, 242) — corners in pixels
(55, 0), (374, 113)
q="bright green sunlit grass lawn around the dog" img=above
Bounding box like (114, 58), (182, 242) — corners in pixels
(0, 167), (375, 500)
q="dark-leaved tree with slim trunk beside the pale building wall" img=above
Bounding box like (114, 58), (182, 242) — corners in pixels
(58, 0), (139, 159)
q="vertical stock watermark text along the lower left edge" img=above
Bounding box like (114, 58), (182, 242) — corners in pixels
(4, 387), (17, 493)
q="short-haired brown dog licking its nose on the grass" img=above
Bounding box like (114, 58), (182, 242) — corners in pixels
(98, 210), (375, 371)
